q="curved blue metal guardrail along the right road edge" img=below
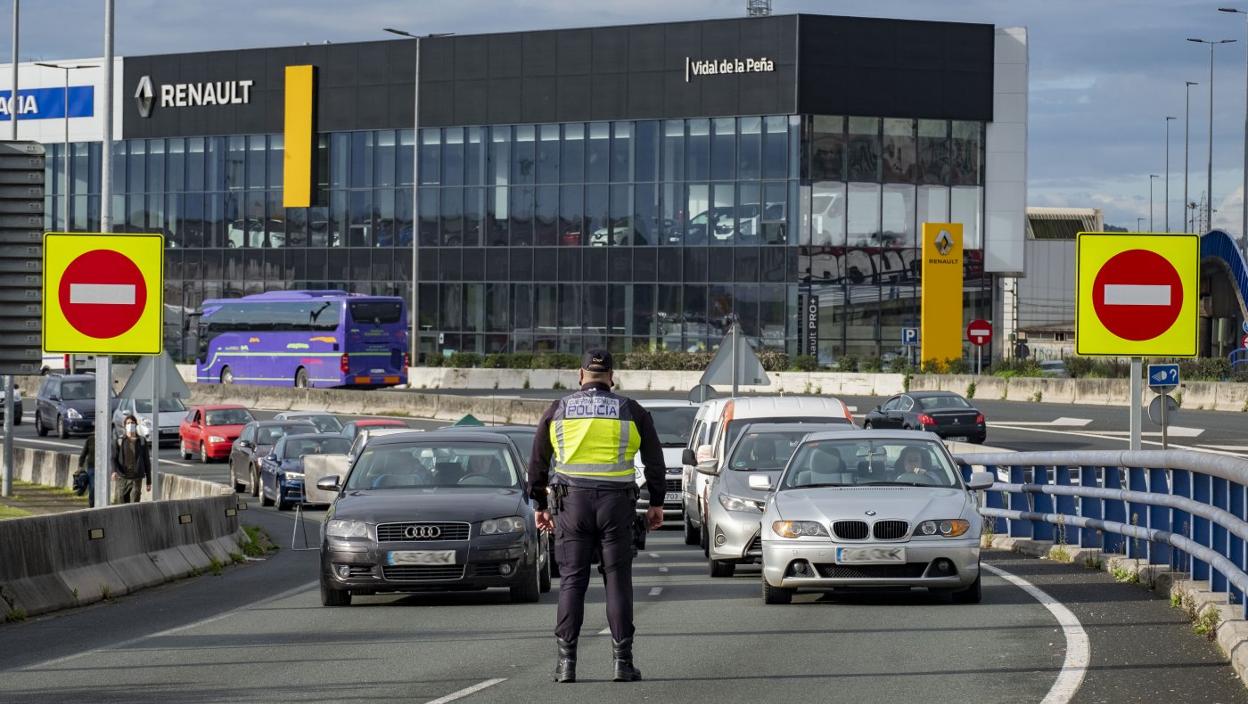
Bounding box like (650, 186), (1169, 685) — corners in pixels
(957, 449), (1248, 618)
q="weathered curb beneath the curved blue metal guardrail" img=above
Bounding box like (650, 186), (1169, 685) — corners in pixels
(982, 535), (1248, 687)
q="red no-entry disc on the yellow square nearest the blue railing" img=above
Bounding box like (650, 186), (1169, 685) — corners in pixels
(1092, 250), (1183, 342)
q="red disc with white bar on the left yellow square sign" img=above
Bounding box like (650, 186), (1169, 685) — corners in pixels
(57, 250), (147, 340)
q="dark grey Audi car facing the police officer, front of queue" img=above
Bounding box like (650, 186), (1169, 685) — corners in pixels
(317, 431), (550, 607)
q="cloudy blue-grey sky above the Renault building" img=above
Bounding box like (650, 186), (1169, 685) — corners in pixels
(0, 0), (1248, 235)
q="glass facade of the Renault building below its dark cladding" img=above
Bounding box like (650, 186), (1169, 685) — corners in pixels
(46, 115), (991, 362)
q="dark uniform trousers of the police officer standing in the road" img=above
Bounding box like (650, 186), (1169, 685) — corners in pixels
(554, 483), (636, 642)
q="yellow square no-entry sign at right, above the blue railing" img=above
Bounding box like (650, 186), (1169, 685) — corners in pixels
(1075, 232), (1201, 357)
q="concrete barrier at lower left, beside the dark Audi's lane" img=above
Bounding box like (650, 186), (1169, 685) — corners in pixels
(0, 497), (243, 619)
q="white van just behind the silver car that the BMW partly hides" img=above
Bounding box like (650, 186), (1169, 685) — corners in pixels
(685, 396), (854, 557)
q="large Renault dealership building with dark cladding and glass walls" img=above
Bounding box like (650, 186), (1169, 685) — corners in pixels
(0, 15), (1027, 362)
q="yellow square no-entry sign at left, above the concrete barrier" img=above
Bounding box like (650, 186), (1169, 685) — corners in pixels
(44, 232), (165, 354)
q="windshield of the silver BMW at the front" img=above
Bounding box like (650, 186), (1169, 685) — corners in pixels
(780, 433), (961, 491)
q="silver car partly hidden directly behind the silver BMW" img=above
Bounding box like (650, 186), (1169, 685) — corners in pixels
(699, 423), (856, 577)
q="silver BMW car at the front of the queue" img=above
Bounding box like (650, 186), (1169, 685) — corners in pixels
(763, 431), (992, 604)
